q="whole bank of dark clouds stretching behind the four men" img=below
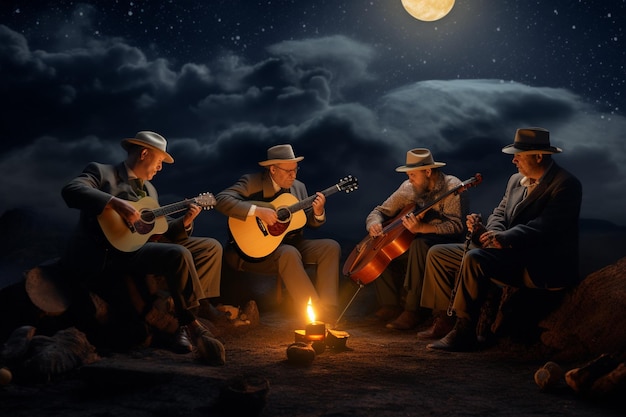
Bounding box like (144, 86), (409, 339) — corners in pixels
(0, 25), (626, 238)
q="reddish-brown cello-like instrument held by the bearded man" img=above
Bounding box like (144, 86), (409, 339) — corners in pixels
(343, 174), (482, 285)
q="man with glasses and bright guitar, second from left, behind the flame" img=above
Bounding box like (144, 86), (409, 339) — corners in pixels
(216, 144), (341, 322)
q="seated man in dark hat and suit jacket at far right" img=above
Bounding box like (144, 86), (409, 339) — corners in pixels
(421, 127), (582, 351)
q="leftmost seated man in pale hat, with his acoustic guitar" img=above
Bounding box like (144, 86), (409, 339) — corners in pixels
(62, 131), (225, 365)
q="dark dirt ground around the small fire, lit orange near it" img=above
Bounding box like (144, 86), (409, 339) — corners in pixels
(0, 283), (624, 417)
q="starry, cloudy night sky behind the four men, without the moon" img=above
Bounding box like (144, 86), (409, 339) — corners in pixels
(0, 0), (626, 250)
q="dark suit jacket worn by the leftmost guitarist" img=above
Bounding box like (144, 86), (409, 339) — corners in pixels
(61, 162), (188, 273)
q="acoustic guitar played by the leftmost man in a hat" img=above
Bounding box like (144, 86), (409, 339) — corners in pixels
(98, 193), (216, 252)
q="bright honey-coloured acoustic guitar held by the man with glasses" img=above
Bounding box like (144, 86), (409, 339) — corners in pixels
(228, 175), (359, 259)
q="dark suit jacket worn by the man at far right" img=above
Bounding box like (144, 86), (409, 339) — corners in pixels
(487, 162), (582, 288)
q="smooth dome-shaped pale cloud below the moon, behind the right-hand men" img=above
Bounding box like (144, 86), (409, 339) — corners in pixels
(378, 80), (626, 224)
